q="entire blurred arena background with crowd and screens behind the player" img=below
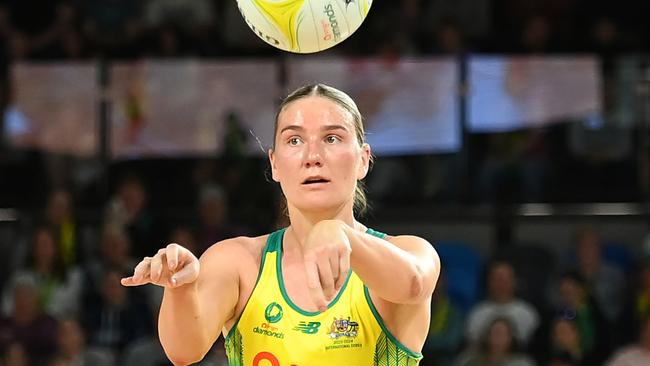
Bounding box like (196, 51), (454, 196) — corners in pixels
(0, 0), (650, 366)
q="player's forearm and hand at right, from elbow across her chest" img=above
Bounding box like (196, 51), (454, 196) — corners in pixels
(304, 220), (440, 311)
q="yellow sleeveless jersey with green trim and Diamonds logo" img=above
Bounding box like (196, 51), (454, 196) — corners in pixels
(225, 228), (422, 366)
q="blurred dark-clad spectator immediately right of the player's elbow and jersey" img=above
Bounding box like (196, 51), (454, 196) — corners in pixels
(422, 272), (465, 366)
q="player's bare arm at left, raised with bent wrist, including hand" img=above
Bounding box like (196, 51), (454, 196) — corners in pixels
(122, 239), (239, 365)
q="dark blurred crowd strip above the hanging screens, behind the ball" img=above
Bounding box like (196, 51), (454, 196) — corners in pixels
(0, 0), (650, 60)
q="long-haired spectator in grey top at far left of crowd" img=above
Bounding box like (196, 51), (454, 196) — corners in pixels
(2, 227), (82, 316)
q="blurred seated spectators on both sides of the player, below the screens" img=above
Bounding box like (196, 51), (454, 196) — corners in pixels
(0, 172), (650, 366)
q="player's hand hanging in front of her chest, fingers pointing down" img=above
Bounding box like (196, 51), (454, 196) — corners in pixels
(303, 220), (352, 312)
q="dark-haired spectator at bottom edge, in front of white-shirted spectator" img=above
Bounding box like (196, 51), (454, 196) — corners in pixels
(455, 318), (535, 366)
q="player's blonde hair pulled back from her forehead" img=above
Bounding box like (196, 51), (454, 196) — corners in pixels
(273, 84), (373, 216)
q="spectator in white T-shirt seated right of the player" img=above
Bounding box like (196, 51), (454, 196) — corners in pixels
(466, 261), (539, 347)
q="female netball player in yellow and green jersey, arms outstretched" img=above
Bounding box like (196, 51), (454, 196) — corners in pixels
(122, 84), (440, 366)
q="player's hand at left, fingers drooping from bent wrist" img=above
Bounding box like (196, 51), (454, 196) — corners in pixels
(121, 244), (201, 288)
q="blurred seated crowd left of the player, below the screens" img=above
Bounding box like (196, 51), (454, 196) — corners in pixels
(0, 167), (262, 366)
